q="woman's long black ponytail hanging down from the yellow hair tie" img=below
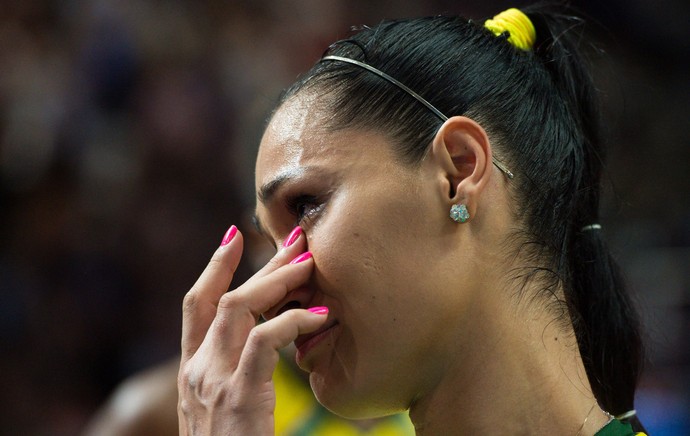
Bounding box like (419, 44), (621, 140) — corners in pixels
(525, 7), (643, 430)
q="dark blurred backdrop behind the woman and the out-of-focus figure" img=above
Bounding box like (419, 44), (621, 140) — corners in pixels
(0, 0), (690, 435)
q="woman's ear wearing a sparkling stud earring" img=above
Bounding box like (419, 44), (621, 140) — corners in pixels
(431, 116), (493, 217)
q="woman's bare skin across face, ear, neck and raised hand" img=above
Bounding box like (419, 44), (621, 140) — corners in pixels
(178, 95), (606, 434)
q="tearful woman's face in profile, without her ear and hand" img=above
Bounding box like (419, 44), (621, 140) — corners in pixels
(256, 96), (478, 417)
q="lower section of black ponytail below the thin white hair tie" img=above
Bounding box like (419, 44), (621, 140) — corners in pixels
(568, 229), (643, 430)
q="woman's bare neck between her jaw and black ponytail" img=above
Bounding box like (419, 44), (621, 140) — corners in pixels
(410, 292), (608, 436)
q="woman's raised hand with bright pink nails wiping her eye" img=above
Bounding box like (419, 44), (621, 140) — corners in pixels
(177, 226), (327, 435)
